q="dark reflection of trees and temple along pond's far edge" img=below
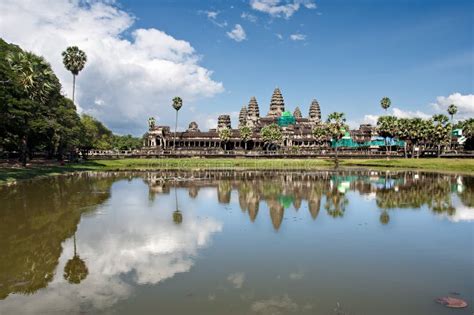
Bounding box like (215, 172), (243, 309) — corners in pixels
(0, 171), (474, 306)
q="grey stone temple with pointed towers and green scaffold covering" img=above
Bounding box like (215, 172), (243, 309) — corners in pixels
(144, 88), (373, 150)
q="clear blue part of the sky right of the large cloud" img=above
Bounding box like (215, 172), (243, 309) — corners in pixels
(122, 0), (474, 127)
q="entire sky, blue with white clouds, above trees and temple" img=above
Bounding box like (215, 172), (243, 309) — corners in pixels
(0, 0), (474, 136)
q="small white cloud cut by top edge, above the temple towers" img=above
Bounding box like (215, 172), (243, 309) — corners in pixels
(250, 0), (316, 19)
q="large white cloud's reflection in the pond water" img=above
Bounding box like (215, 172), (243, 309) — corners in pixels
(0, 179), (222, 314)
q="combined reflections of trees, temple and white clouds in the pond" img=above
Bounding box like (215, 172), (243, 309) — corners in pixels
(0, 171), (474, 314)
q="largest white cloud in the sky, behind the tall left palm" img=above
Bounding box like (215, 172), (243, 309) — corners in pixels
(0, 0), (223, 134)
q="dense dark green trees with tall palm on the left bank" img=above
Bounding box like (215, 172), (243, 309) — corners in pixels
(0, 39), (142, 164)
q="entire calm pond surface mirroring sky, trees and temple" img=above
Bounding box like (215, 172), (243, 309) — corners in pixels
(0, 171), (474, 315)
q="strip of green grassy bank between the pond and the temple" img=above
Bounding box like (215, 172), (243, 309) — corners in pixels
(0, 158), (474, 184)
